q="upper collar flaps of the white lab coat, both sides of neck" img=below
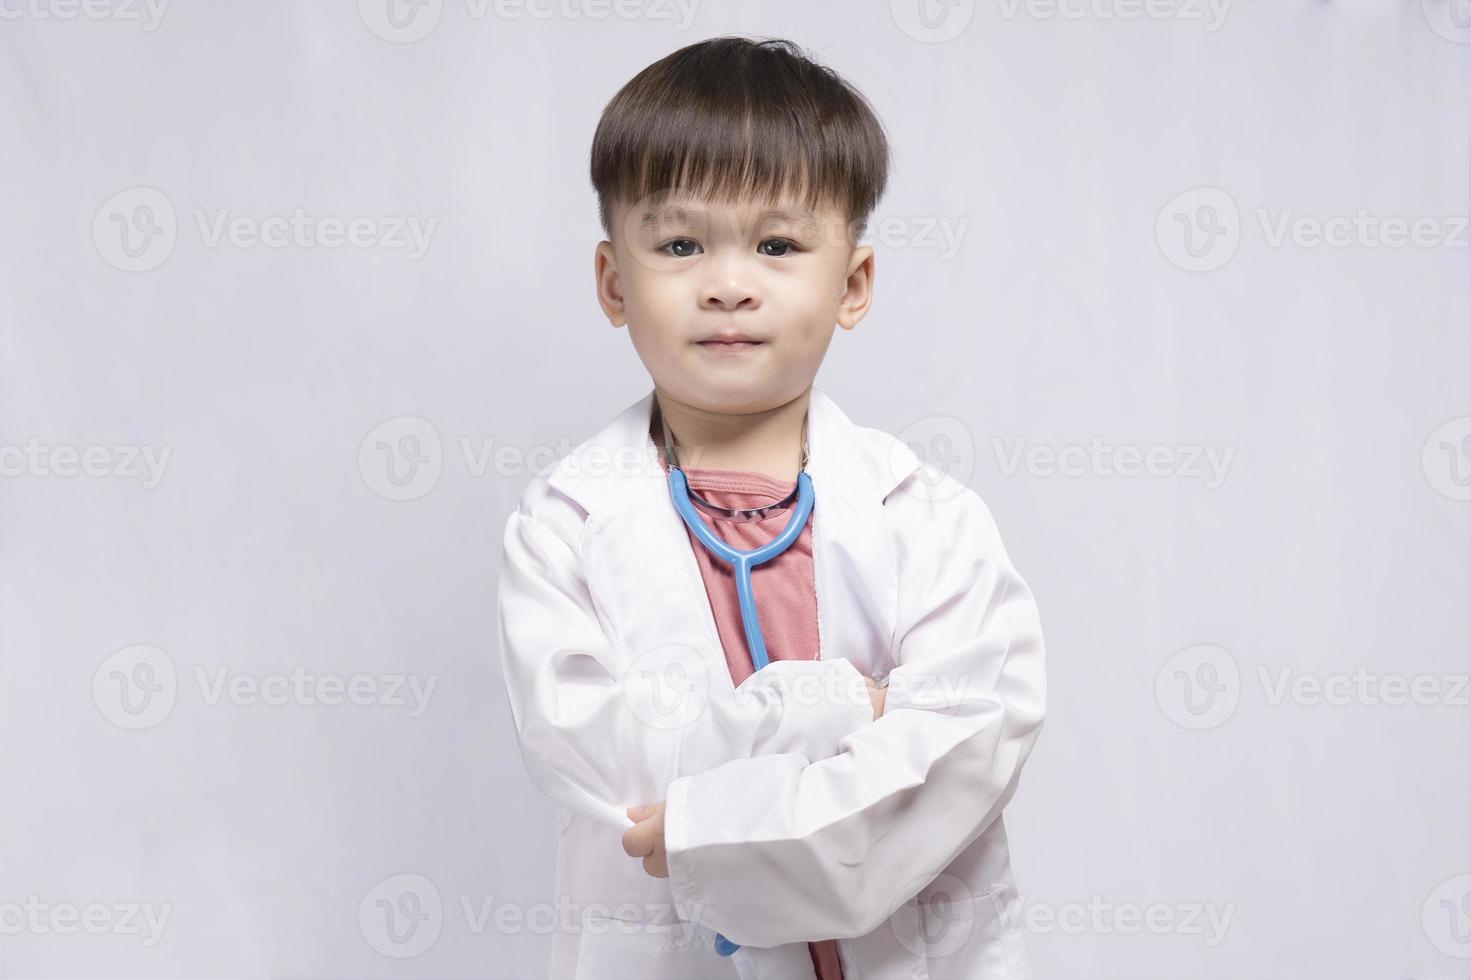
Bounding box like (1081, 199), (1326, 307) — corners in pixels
(549, 386), (919, 515)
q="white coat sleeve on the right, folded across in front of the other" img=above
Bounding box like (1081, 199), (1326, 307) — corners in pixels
(665, 471), (1046, 946)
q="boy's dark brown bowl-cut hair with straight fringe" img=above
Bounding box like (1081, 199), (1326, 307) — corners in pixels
(591, 37), (888, 241)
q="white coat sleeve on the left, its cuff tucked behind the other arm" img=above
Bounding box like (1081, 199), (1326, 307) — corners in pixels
(497, 488), (874, 828)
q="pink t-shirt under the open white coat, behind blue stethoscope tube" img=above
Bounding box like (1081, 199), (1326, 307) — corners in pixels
(659, 458), (843, 980)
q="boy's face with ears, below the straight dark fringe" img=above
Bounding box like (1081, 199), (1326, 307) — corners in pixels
(596, 189), (874, 413)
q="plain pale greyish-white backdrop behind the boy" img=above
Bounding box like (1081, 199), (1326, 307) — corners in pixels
(0, 0), (1471, 980)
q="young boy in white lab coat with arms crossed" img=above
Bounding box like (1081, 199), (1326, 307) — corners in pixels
(499, 38), (1046, 980)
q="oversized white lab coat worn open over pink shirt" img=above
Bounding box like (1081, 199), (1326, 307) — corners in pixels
(499, 387), (1046, 980)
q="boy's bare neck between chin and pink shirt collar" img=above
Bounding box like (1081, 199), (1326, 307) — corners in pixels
(649, 386), (812, 483)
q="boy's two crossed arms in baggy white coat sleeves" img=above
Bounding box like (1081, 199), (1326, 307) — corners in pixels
(500, 473), (1046, 946)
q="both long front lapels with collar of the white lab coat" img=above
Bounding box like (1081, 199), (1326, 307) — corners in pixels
(552, 386), (919, 679)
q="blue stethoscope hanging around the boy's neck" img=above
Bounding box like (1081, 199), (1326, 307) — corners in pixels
(655, 399), (812, 956)
